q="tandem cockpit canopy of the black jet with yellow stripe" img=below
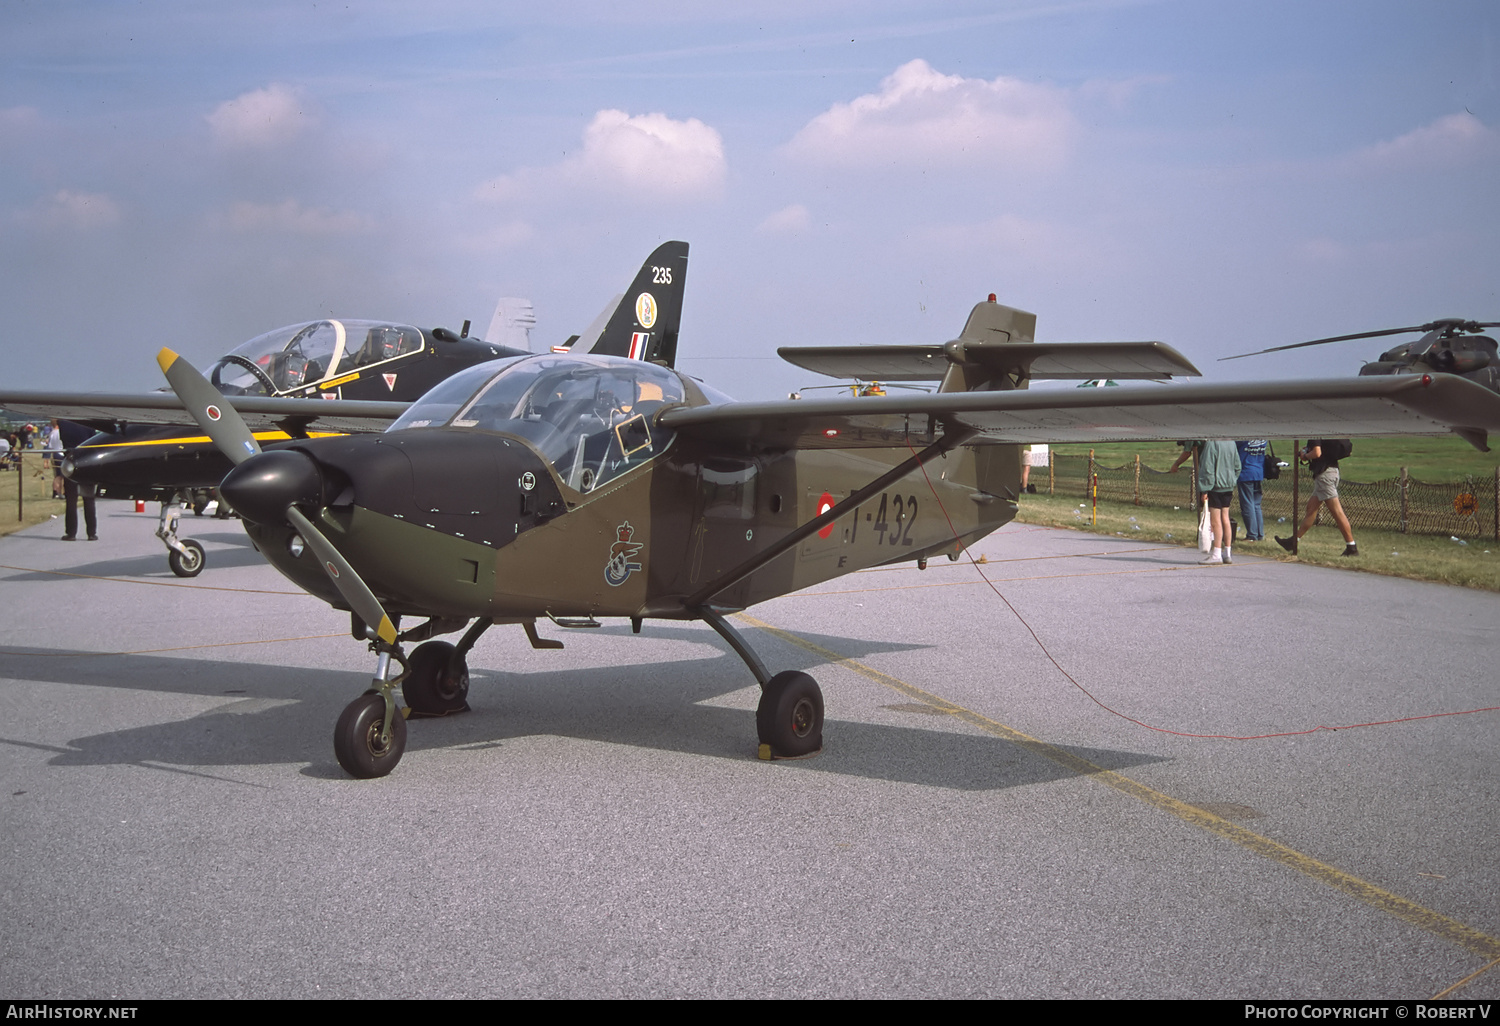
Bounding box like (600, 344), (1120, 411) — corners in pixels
(209, 321), (425, 396)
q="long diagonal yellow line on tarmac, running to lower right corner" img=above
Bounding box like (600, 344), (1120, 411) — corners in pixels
(737, 614), (1500, 972)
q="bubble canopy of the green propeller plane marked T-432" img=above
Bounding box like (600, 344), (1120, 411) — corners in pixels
(390, 354), (683, 492)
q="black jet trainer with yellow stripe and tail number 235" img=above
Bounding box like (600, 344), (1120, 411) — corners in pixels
(0, 245), (683, 578)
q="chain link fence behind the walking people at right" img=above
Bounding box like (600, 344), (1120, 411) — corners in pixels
(1032, 453), (1500, 542)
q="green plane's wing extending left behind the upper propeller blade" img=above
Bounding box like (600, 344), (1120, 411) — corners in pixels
(0, 392), (410, 434)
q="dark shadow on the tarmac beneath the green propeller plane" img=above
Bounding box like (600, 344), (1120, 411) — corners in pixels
(0, 642), (1160, 791)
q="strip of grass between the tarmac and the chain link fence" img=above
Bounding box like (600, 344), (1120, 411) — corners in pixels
(1016, 489), (1500, 591)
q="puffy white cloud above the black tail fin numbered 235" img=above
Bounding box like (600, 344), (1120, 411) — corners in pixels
(479, 110), (729, 201)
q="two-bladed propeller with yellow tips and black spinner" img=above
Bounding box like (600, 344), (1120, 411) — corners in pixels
(156, 348), (396, 645)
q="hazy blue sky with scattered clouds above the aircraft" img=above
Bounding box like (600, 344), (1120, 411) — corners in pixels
(0, 0), (1500, 399)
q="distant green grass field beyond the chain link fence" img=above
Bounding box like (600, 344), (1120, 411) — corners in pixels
(1052, 438), (1500, 485)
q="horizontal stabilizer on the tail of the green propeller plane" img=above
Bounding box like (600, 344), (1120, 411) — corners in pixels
(777, 339), (1202, 381)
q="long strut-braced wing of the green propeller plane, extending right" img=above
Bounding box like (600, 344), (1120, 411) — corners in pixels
(659, 374), (1500, 452)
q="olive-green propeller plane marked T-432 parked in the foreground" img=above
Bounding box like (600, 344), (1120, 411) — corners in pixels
(132, 250), (1500, 779)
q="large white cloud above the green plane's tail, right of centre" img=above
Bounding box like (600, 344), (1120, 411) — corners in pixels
(786, 60), (1076, 170)
